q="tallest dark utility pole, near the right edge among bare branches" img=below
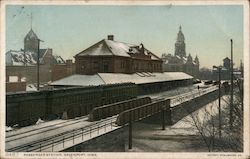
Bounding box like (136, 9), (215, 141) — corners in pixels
(229, 39), (233, 129)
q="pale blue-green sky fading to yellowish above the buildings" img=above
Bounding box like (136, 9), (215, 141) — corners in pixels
(6, 5), (243, 68)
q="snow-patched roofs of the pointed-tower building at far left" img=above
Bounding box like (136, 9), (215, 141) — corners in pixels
(5, 49), (65, 66)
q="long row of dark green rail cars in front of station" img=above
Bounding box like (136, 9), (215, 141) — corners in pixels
(6, 83), (137, 126)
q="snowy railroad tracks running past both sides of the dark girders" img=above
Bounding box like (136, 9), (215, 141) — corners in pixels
(6, 87), (217, 152)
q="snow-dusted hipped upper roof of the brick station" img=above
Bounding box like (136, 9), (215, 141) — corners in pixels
(76, 39), (160, 60)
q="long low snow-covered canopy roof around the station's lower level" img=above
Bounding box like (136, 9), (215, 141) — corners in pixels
(50, 72), (193, 86)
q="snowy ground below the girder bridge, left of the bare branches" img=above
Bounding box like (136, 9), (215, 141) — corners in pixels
(126, 96), (230, 152)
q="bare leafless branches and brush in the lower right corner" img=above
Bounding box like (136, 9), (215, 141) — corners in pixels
(173, 84), (243, 152)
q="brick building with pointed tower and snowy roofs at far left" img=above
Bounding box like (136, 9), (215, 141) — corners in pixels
(6, 29), (74, 87)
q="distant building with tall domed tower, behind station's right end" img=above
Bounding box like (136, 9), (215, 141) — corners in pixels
(161, 26), (200, 78)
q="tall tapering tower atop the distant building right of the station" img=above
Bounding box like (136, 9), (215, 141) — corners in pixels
(175, 26), (186, 57)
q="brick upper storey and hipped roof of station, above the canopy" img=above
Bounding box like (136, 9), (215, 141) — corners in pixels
(75, 35), (162, 74)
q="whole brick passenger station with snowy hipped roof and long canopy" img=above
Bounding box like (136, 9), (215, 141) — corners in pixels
(50, 35), (193, 94)
